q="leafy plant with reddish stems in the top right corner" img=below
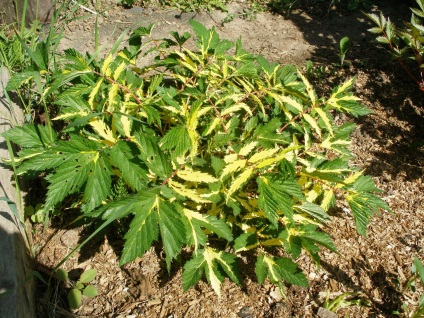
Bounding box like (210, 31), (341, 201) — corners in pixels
(366, 0), (424, 92)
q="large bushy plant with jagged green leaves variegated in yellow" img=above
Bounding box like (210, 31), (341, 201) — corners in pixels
(4, 20), (389, 295)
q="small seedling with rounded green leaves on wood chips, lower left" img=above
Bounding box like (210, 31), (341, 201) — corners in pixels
(56, 268), (98, 309)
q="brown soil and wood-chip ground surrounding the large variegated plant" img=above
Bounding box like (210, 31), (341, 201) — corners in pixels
(32, 1), (424, 318)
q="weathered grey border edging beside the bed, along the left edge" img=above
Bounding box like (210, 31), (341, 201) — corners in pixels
(0, 67), (35, 318)
